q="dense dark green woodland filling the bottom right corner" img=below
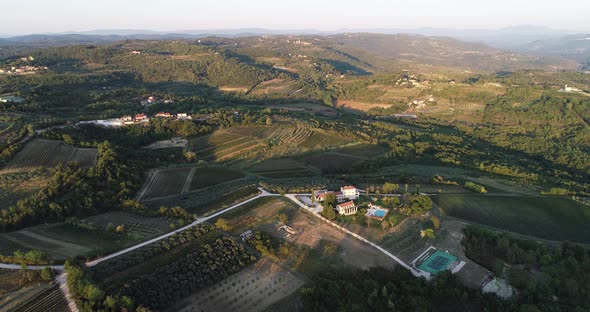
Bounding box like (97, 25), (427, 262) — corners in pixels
(463, 227), (590, 311)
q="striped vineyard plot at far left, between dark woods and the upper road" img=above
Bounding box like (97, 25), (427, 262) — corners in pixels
(8, 139), (98, 169)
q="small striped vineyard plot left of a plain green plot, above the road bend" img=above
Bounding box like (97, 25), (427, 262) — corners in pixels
(139, 168), (191, 201)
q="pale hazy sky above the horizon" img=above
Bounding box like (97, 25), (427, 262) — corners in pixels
(0, 0), (590, 35)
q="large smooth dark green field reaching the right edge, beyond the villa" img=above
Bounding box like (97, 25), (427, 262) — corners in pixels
(432, 194), (590, 243)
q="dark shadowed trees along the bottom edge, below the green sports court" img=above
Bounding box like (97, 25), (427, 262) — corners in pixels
(301, 267), (512, 312)
